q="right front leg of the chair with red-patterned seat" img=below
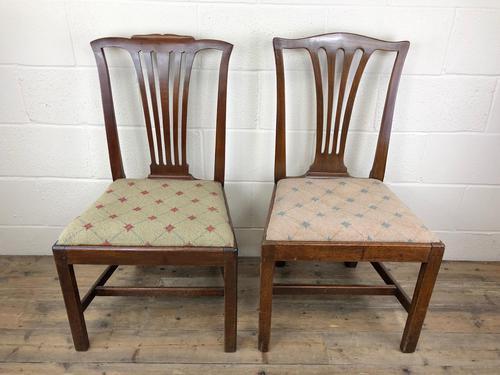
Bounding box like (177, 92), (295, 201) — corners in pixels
(224, 249), (238, 353)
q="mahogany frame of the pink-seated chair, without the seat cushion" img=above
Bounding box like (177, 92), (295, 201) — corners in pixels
(258, 33), (444, 353)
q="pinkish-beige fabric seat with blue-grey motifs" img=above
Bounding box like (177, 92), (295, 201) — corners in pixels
(266, 177), (439, 243)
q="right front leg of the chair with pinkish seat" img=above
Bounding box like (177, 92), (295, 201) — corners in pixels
(400, 245), (444, 353)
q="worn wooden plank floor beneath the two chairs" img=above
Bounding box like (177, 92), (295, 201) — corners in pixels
(0, 257), (500, 375)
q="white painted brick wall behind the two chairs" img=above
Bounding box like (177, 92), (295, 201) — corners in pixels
(0, 0), (500, 260)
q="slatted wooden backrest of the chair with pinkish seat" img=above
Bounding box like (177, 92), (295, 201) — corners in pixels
(273, 33), (410, 181)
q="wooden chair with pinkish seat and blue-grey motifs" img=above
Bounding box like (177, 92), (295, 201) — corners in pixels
(259, 33), (444, 353)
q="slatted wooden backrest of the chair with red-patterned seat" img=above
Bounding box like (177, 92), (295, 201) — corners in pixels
(91, 34), (233, 183)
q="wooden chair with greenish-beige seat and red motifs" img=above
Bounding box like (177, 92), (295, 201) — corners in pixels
(53, 35), (238, 352)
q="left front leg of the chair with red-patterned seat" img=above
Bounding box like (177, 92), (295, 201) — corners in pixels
(54, 252), (89, 351)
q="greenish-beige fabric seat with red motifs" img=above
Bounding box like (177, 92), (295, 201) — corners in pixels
(57, 179), (235, 247)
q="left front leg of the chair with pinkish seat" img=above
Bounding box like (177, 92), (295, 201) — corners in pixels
(259, 247), (275, 352)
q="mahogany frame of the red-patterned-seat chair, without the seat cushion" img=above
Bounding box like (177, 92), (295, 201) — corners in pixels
(52, 34), (238, 352)
